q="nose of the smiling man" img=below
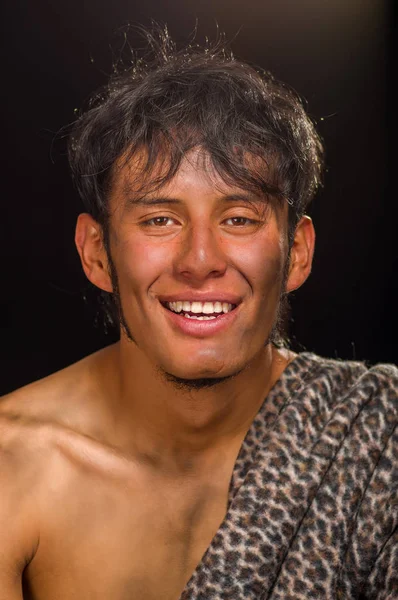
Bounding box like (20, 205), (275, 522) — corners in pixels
(175, 225), (227, 283)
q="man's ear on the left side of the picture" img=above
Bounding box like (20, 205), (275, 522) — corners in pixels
(75, 213), (113, 292)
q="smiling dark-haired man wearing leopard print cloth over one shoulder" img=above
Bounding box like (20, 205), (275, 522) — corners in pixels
(0, 29), (398, 600)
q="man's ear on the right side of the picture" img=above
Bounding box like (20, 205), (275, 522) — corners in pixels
(286, 216), (315, 292)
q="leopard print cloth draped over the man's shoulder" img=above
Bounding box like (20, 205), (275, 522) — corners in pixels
(180, 353), (398, 600)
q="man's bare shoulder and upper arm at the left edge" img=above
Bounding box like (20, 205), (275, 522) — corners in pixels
(0, 344), (124, 598)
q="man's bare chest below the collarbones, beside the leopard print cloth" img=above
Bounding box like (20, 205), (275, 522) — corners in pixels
(24, 462), (230, 600)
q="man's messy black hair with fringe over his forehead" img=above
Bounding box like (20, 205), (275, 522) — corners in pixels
(69, 27), (323, 344)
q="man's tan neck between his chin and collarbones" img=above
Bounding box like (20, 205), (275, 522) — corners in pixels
(93, 338), (294, 469)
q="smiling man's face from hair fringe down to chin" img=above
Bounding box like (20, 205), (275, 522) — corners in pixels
(102, 152), (288, 379)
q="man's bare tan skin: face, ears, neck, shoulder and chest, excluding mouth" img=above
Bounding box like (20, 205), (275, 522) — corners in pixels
(0, 151), (314, 600)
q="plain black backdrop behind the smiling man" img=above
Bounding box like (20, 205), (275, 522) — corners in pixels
(0, 0), (398, 393)
